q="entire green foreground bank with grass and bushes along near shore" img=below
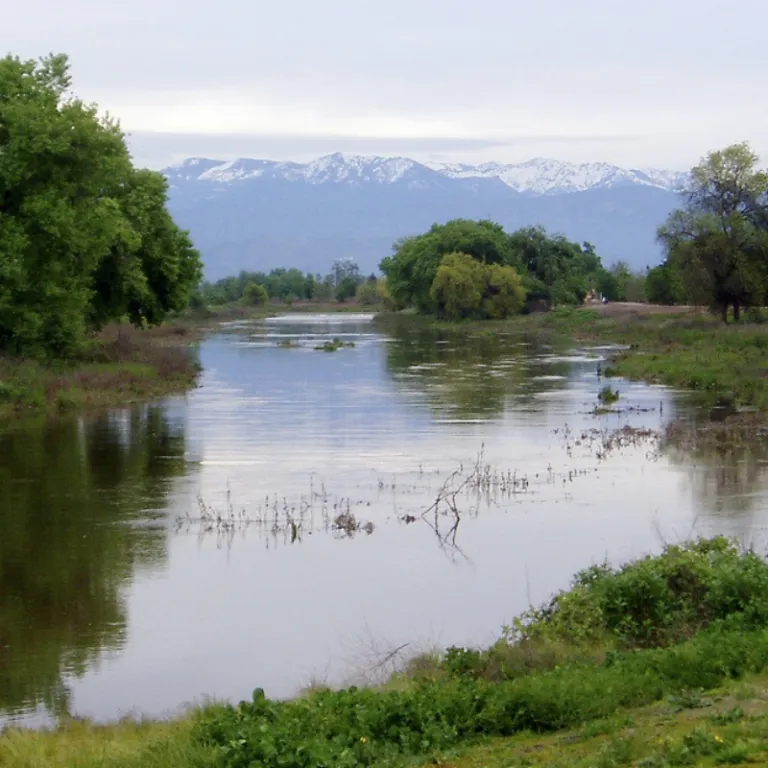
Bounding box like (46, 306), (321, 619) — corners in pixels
(7, 539), (768, 768)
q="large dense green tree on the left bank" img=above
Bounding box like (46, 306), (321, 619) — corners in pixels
(0, 55), (201, 355)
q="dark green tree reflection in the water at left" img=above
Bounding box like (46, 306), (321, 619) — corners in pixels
(0, 407), (186, 715)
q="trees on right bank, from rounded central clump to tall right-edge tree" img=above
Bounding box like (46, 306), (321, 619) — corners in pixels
(380, 143), (768, 321)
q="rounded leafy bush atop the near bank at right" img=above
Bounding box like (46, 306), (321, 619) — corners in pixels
(510, 538), (768, 647)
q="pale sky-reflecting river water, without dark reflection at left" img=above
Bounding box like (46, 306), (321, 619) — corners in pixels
(6, 315), (765, 728)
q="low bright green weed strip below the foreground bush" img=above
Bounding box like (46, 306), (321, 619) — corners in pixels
(196, 627), (768, 768)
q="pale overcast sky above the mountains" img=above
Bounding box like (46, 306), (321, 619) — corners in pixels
(6, 0), (768, 169)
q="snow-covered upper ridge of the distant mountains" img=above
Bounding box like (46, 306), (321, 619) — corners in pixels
(164, 152), (686, 196)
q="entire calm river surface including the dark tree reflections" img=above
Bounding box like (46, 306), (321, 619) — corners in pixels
(0, 315), (768, 725)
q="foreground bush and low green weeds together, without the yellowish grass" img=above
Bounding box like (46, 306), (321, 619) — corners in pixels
(194, 538), (768, 768)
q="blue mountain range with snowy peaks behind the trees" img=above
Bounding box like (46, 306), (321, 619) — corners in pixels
(164, 154), (685, 279)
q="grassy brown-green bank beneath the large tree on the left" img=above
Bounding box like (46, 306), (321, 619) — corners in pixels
(0, 323), (199, 421)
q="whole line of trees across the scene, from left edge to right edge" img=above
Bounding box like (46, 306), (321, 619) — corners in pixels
(0, 55), (768, 364)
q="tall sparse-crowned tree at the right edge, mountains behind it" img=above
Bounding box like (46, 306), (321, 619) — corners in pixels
(658, 143), (768, 321)
